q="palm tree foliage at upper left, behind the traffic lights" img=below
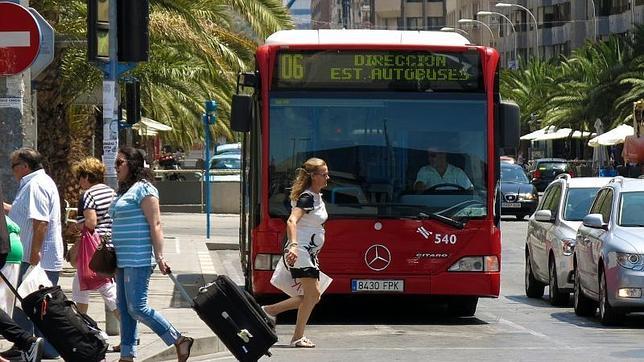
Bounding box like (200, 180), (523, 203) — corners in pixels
(31, 0), (293, 148)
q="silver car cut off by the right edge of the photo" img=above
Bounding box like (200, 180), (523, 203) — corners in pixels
(573, 177), (644, 325)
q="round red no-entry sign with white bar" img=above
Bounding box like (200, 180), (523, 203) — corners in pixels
(0, 1), (40, 76)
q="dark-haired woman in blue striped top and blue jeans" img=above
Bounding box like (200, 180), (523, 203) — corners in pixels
(110, 146), (194, 362)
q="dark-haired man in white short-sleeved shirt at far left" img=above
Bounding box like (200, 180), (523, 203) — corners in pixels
(0, 147), (63, 358)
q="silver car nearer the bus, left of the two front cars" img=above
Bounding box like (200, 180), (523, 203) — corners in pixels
(525, 173), (610, 305)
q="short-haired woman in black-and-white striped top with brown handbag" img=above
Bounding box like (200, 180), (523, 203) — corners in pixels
(72, 157), (119, 318)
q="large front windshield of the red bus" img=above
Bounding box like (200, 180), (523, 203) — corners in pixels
(269, 91), (487, 218)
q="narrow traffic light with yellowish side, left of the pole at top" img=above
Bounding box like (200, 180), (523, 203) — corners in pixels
(87, 0), (114, 62)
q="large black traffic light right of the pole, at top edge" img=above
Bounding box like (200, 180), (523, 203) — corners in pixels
(116, 0), (150, 62)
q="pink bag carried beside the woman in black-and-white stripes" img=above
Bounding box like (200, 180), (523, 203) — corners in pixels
(76, 227), (112, 290)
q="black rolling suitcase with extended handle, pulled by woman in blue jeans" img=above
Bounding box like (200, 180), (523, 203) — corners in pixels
(168, 273), (277, 361)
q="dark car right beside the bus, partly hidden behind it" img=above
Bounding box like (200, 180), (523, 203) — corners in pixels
(501, 162), (539, 220)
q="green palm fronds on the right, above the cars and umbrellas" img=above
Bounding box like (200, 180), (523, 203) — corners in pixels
(501, 26), (644, 131)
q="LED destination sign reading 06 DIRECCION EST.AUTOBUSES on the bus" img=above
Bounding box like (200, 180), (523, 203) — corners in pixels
(273, 50), (483, 91)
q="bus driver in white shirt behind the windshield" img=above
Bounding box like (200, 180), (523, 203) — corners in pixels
(414, 150), (473, 192)
